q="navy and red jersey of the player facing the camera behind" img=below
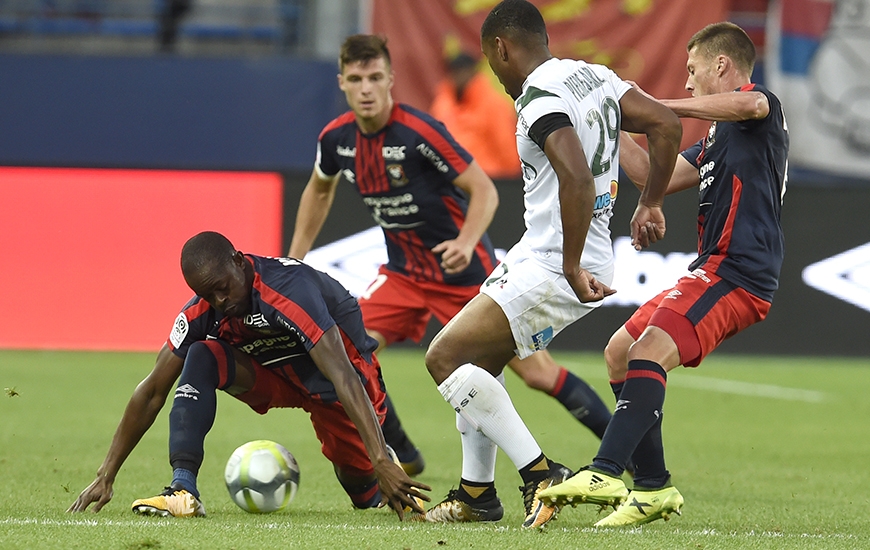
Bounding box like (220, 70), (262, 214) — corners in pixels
(315, 103), (496, 286)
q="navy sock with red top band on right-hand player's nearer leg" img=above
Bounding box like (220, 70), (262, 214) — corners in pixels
(592, 359), (667, 476)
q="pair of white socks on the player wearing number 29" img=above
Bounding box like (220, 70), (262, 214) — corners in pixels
(438, 363), (541, 472)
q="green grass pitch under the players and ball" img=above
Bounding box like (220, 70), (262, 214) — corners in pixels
(0, 348), (870, 550)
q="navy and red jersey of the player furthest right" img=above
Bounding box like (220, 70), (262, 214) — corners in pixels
(682, 84), (789, 302)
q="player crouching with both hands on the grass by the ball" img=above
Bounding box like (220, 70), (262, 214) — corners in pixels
(69, 232), (430, 519)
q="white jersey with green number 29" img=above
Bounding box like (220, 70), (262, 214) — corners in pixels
(515, 58), (631, 272)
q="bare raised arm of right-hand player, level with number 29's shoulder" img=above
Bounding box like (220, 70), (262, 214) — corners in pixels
(660, 92), (769, 122)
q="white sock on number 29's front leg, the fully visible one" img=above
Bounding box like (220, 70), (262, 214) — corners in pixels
(438, 363), (541, 469)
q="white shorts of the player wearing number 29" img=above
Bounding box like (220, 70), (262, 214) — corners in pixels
(480, 246), (613, 359)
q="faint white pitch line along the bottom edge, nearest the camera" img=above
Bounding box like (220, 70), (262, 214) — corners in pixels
(0, 516), (863, 540)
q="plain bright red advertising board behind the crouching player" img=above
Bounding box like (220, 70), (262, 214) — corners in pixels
(0, 168), (283, 351)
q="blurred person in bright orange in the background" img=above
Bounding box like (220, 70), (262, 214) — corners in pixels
(429, 53), (520, 179)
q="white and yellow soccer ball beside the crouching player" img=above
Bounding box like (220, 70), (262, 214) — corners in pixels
(224, 440), (299, 513)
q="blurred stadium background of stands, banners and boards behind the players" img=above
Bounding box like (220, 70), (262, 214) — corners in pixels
(0, 0), (870, 356)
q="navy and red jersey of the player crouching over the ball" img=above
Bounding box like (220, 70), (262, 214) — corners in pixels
(168, 255), (382, 403)
